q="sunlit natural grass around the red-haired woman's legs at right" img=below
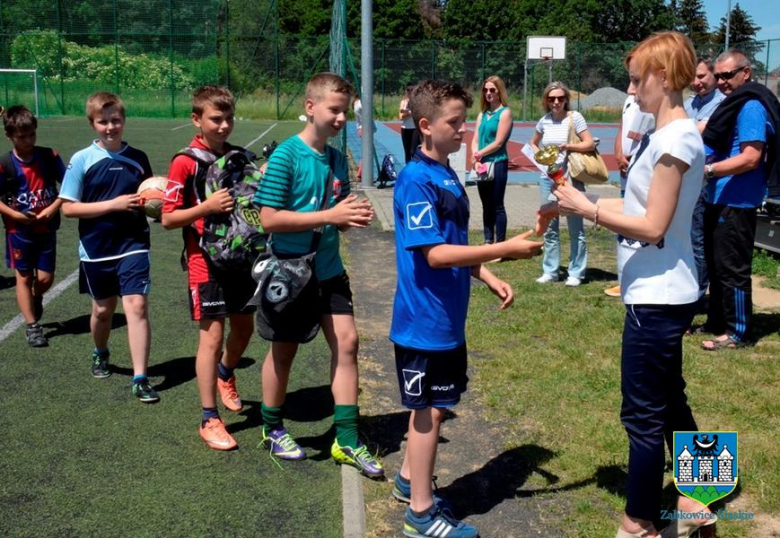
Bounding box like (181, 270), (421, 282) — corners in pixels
(468, 229), (780, 538)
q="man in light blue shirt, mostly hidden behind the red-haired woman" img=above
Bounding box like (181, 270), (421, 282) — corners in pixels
(684, 57), (726, 310)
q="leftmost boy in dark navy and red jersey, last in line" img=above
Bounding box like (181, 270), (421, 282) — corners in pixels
(0, 106), (65, 347)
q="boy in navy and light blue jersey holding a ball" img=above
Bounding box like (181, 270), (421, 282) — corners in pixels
(60, 92), (159, 403)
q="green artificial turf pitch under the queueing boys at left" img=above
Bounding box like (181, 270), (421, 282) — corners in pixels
(0, 118), (342, 537)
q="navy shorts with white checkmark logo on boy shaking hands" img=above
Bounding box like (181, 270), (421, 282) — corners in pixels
(395, 344), (469, 409)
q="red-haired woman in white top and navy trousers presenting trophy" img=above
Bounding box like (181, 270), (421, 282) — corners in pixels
(554, 32), (715, 538)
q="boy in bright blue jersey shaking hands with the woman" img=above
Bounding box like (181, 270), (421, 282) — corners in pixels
(390, 80), (543, 538)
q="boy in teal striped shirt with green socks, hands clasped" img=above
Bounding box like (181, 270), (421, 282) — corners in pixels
(255, 73), (384, 477)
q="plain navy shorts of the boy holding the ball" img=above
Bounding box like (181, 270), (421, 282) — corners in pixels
(79, 252), (151, 300)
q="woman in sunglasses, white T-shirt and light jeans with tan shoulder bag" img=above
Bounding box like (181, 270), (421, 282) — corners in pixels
(531, 82), (595, 286)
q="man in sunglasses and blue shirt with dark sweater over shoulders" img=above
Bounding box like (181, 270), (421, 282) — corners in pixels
(702, 50), (780, 351)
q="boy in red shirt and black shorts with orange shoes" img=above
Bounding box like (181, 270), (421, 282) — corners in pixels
(162, 86), (256, 450)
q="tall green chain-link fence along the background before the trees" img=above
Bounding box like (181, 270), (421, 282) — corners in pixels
(0, 0), (780, 119)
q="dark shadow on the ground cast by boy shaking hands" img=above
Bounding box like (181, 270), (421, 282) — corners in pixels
(438, 445), (597, 518)
